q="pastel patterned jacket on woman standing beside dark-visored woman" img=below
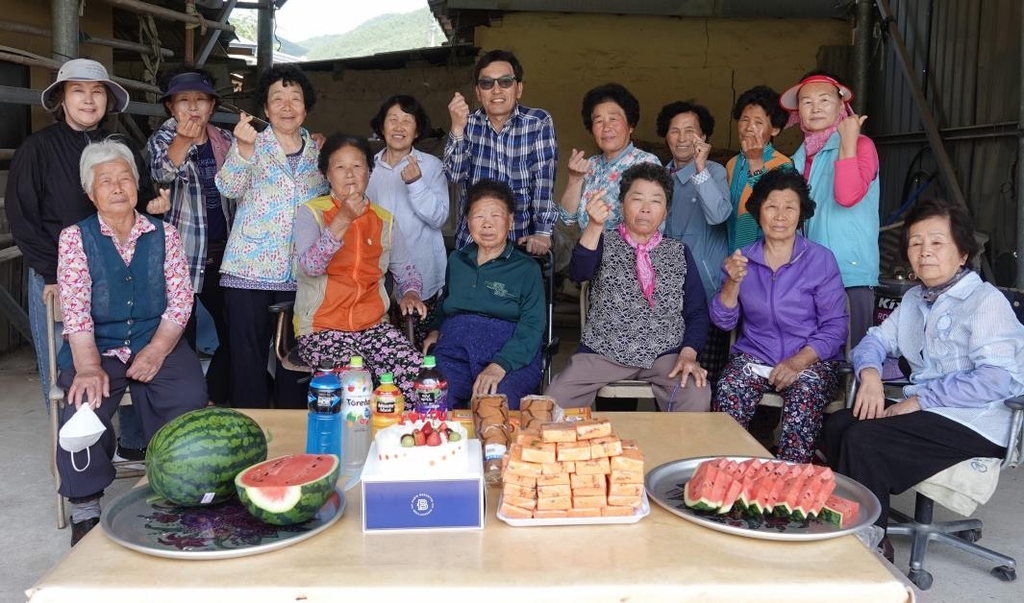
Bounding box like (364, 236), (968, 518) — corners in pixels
(217, 128), (328, 283)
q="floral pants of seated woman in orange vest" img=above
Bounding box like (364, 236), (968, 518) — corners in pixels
(298, 322), (423, 411)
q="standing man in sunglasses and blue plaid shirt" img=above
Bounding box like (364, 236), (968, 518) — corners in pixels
(444, 50), (558, 255)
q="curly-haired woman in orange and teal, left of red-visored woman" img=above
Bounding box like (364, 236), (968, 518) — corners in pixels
(725, 86), (793, 253)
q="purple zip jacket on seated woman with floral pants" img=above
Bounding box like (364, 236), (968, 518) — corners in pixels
(711, 234), (849, 367)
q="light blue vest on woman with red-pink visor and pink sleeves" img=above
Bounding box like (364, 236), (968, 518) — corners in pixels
(793, 132), (879, 287)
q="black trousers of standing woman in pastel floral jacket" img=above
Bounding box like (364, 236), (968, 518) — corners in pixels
(224, 287), (306, 408)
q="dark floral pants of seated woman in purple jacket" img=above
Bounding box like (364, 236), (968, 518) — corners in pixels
(712, 353), (839, 463)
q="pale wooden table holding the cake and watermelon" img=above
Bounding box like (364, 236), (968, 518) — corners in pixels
(27, 411), (912, 603)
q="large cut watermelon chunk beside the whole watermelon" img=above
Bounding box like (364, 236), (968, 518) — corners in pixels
(234, 455), (340, 525)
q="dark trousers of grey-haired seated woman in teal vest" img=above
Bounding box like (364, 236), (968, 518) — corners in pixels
(56, 339), (207, 503)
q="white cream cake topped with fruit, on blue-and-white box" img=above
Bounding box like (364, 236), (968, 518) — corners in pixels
(374, 413), (468, 471)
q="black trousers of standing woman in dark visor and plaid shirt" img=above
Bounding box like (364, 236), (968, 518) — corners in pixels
(184, 241), (231, 404)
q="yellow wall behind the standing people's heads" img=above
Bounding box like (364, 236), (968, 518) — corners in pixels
(475, 12), (851, 161)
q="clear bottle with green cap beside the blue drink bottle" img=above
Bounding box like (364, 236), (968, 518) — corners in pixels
(339, 356), (374, 475)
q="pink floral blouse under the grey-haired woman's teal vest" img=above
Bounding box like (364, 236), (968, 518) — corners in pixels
(57, 212), (193, 362)
